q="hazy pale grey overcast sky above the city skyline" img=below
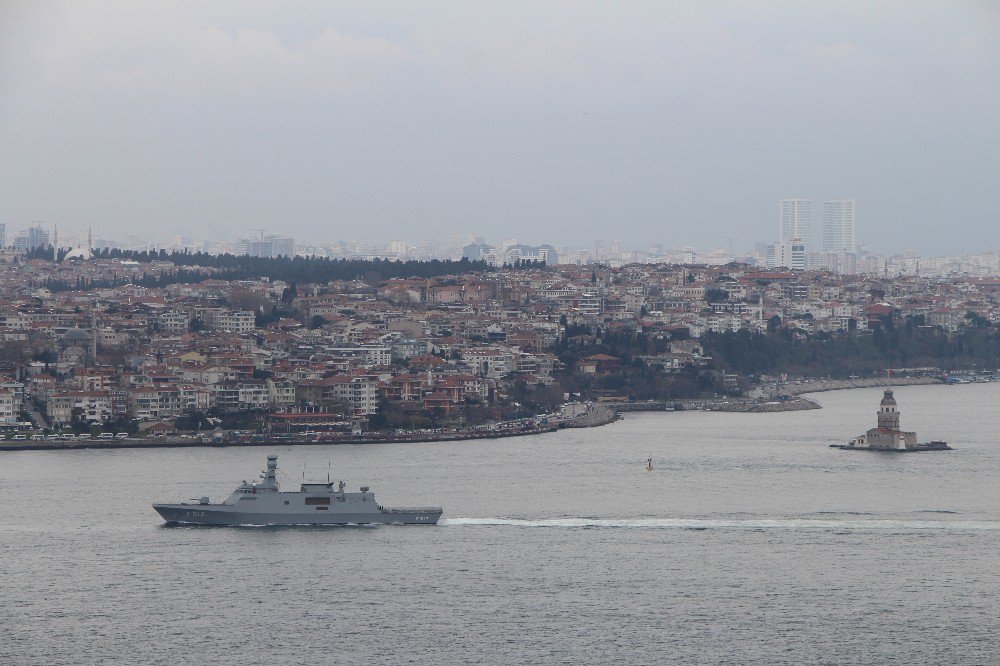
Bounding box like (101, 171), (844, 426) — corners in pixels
(0, 0), (1000, 254)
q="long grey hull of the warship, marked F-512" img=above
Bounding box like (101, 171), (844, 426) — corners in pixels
(153, 504), (442, 526)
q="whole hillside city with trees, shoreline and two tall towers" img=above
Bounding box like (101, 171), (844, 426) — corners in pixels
(0, 199), (1000, 439)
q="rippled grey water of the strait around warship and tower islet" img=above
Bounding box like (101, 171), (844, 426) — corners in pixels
(0, 385), (1000, 664)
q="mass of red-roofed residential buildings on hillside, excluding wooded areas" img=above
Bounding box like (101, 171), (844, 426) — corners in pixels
(0, 244), (1000, 432)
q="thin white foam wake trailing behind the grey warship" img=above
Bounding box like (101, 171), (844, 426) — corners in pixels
(438, 518), (1000, 531)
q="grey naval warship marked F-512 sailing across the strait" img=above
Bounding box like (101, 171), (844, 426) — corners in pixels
(153, 455), (443, 525)
